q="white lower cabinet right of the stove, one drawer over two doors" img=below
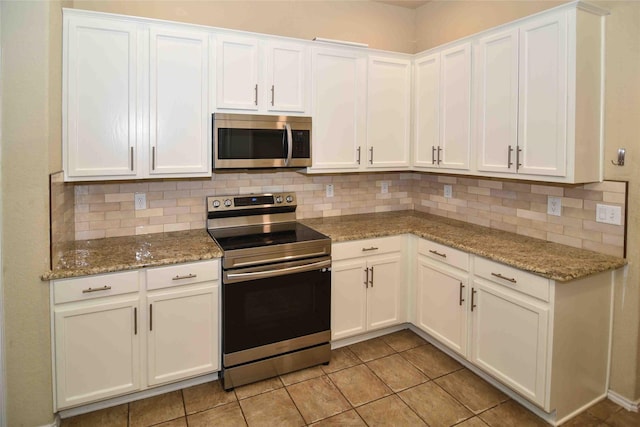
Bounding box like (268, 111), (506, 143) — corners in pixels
(331, 236), (406, 340)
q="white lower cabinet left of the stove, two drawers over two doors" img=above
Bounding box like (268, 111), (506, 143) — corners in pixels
(51, 260), (220, 410)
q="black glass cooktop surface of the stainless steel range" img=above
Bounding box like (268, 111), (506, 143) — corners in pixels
(208, 222), (329, 251)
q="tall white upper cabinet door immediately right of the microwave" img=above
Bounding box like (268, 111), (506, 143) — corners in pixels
(312, 49), (367, 170)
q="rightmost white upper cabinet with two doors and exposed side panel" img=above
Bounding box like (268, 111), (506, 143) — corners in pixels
(474, 5), (605, 183)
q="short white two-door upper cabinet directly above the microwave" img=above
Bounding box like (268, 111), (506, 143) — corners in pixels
(216, 35), (309, 114)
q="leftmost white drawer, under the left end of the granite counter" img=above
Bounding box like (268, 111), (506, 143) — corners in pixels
(53, 270), (139, 304)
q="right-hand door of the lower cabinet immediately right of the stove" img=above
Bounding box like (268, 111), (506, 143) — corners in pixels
(367, 253), (404, 330)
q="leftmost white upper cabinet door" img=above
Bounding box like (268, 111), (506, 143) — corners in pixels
(62, 17), (138, 180)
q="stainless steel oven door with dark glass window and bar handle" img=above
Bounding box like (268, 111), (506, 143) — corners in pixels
(222, 257), (331, 367)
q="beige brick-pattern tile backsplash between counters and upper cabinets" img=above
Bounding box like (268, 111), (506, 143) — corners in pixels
(63, 171), (626, 256)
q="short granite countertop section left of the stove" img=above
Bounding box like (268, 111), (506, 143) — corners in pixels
(42, 230), (222, 280)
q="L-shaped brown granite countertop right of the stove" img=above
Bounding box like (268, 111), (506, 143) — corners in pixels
(300, 211), (627, 282)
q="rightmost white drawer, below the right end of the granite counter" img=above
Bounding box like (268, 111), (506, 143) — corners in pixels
(474, 257), (550, 301)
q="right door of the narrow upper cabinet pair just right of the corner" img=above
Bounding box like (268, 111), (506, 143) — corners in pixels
(436, 43), (471, 169)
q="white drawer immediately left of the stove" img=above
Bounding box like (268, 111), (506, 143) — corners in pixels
(147, 260), (220, 290)
